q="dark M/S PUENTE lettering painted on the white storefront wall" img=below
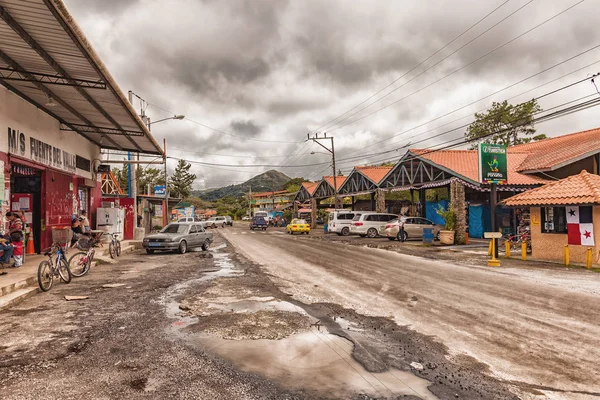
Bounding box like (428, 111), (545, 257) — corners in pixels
(8, 127), (77, 173)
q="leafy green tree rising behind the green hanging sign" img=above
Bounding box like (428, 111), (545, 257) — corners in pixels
(465, 99), (546, 149)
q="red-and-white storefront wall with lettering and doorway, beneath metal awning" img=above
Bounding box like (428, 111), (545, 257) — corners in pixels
(0, 87), (100, 253)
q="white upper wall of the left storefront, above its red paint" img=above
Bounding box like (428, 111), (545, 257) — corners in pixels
(0, 86), (100, 179)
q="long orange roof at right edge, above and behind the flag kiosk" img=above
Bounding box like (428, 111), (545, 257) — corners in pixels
(508, 128), (600, 172)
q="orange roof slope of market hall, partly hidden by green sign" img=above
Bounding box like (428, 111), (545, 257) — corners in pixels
(410, 149), (551, 185)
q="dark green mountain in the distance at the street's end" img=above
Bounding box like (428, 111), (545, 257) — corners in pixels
(192, 169), (291, 201)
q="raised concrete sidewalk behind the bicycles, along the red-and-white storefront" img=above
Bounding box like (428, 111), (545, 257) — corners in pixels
(0, 240), (141, 310)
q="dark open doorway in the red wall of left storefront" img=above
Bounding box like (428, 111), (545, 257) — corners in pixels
(10, 163), (42, 254)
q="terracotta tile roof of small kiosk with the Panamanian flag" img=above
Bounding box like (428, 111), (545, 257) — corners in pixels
(504, 170), (600, 207)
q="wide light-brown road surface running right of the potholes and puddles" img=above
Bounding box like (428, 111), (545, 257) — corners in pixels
(222, 227), (600, 399)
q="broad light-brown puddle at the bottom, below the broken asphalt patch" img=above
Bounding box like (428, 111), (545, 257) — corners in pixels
(196, 328), (438, 400)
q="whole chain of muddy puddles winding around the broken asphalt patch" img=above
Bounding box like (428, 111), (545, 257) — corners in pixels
(161, 246), (438, 400)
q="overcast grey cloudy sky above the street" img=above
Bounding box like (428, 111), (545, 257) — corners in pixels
(64, 0), (600, 188)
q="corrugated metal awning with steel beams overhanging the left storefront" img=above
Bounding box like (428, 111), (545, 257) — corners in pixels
(0, 0), (163, 154)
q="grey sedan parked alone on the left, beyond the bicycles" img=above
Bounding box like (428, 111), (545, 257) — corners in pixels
(142, 222), (213, 254)
